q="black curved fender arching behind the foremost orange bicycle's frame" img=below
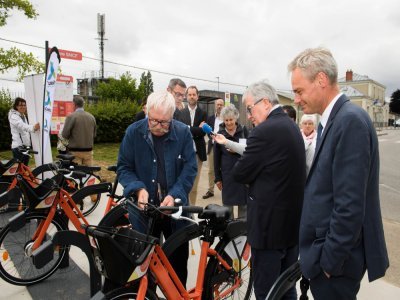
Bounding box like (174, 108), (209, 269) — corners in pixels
(162, 223), (202, 257)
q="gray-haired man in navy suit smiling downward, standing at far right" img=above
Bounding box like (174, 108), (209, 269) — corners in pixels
(288, 48), (389, 299)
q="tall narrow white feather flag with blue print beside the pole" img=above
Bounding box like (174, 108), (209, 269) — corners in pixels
(43, 47), (61, 162)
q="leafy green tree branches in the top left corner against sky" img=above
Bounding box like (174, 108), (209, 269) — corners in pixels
(0, 0), (45, 80)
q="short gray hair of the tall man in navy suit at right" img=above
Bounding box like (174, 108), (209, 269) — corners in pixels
(288, 47), (338, 84)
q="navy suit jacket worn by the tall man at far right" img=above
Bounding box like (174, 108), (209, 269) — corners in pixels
(300, 95), (389, 280)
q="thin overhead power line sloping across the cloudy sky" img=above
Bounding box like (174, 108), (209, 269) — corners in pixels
(0, 37), (247, 87)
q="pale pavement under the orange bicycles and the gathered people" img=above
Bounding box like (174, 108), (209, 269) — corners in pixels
(0, 162), (400, 300)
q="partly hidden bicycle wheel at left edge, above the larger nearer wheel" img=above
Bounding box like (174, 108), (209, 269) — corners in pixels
(0, 182), (25, 229)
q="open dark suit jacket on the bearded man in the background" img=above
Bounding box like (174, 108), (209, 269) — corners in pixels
(179, 106), (207, 161)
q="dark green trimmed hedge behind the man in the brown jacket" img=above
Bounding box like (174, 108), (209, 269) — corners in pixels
(0, 99), (141, 150)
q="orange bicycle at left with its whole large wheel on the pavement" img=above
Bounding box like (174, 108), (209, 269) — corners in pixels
(0, 166), (111, 285)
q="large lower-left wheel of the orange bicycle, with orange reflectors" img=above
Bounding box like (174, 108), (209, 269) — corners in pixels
(0, 213), (68, 286)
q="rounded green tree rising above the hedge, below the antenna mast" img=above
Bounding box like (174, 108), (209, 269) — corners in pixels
(95, 72), (139, 101)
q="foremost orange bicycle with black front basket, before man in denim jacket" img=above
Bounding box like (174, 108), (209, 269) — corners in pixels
(86, 200), (253, 300)
